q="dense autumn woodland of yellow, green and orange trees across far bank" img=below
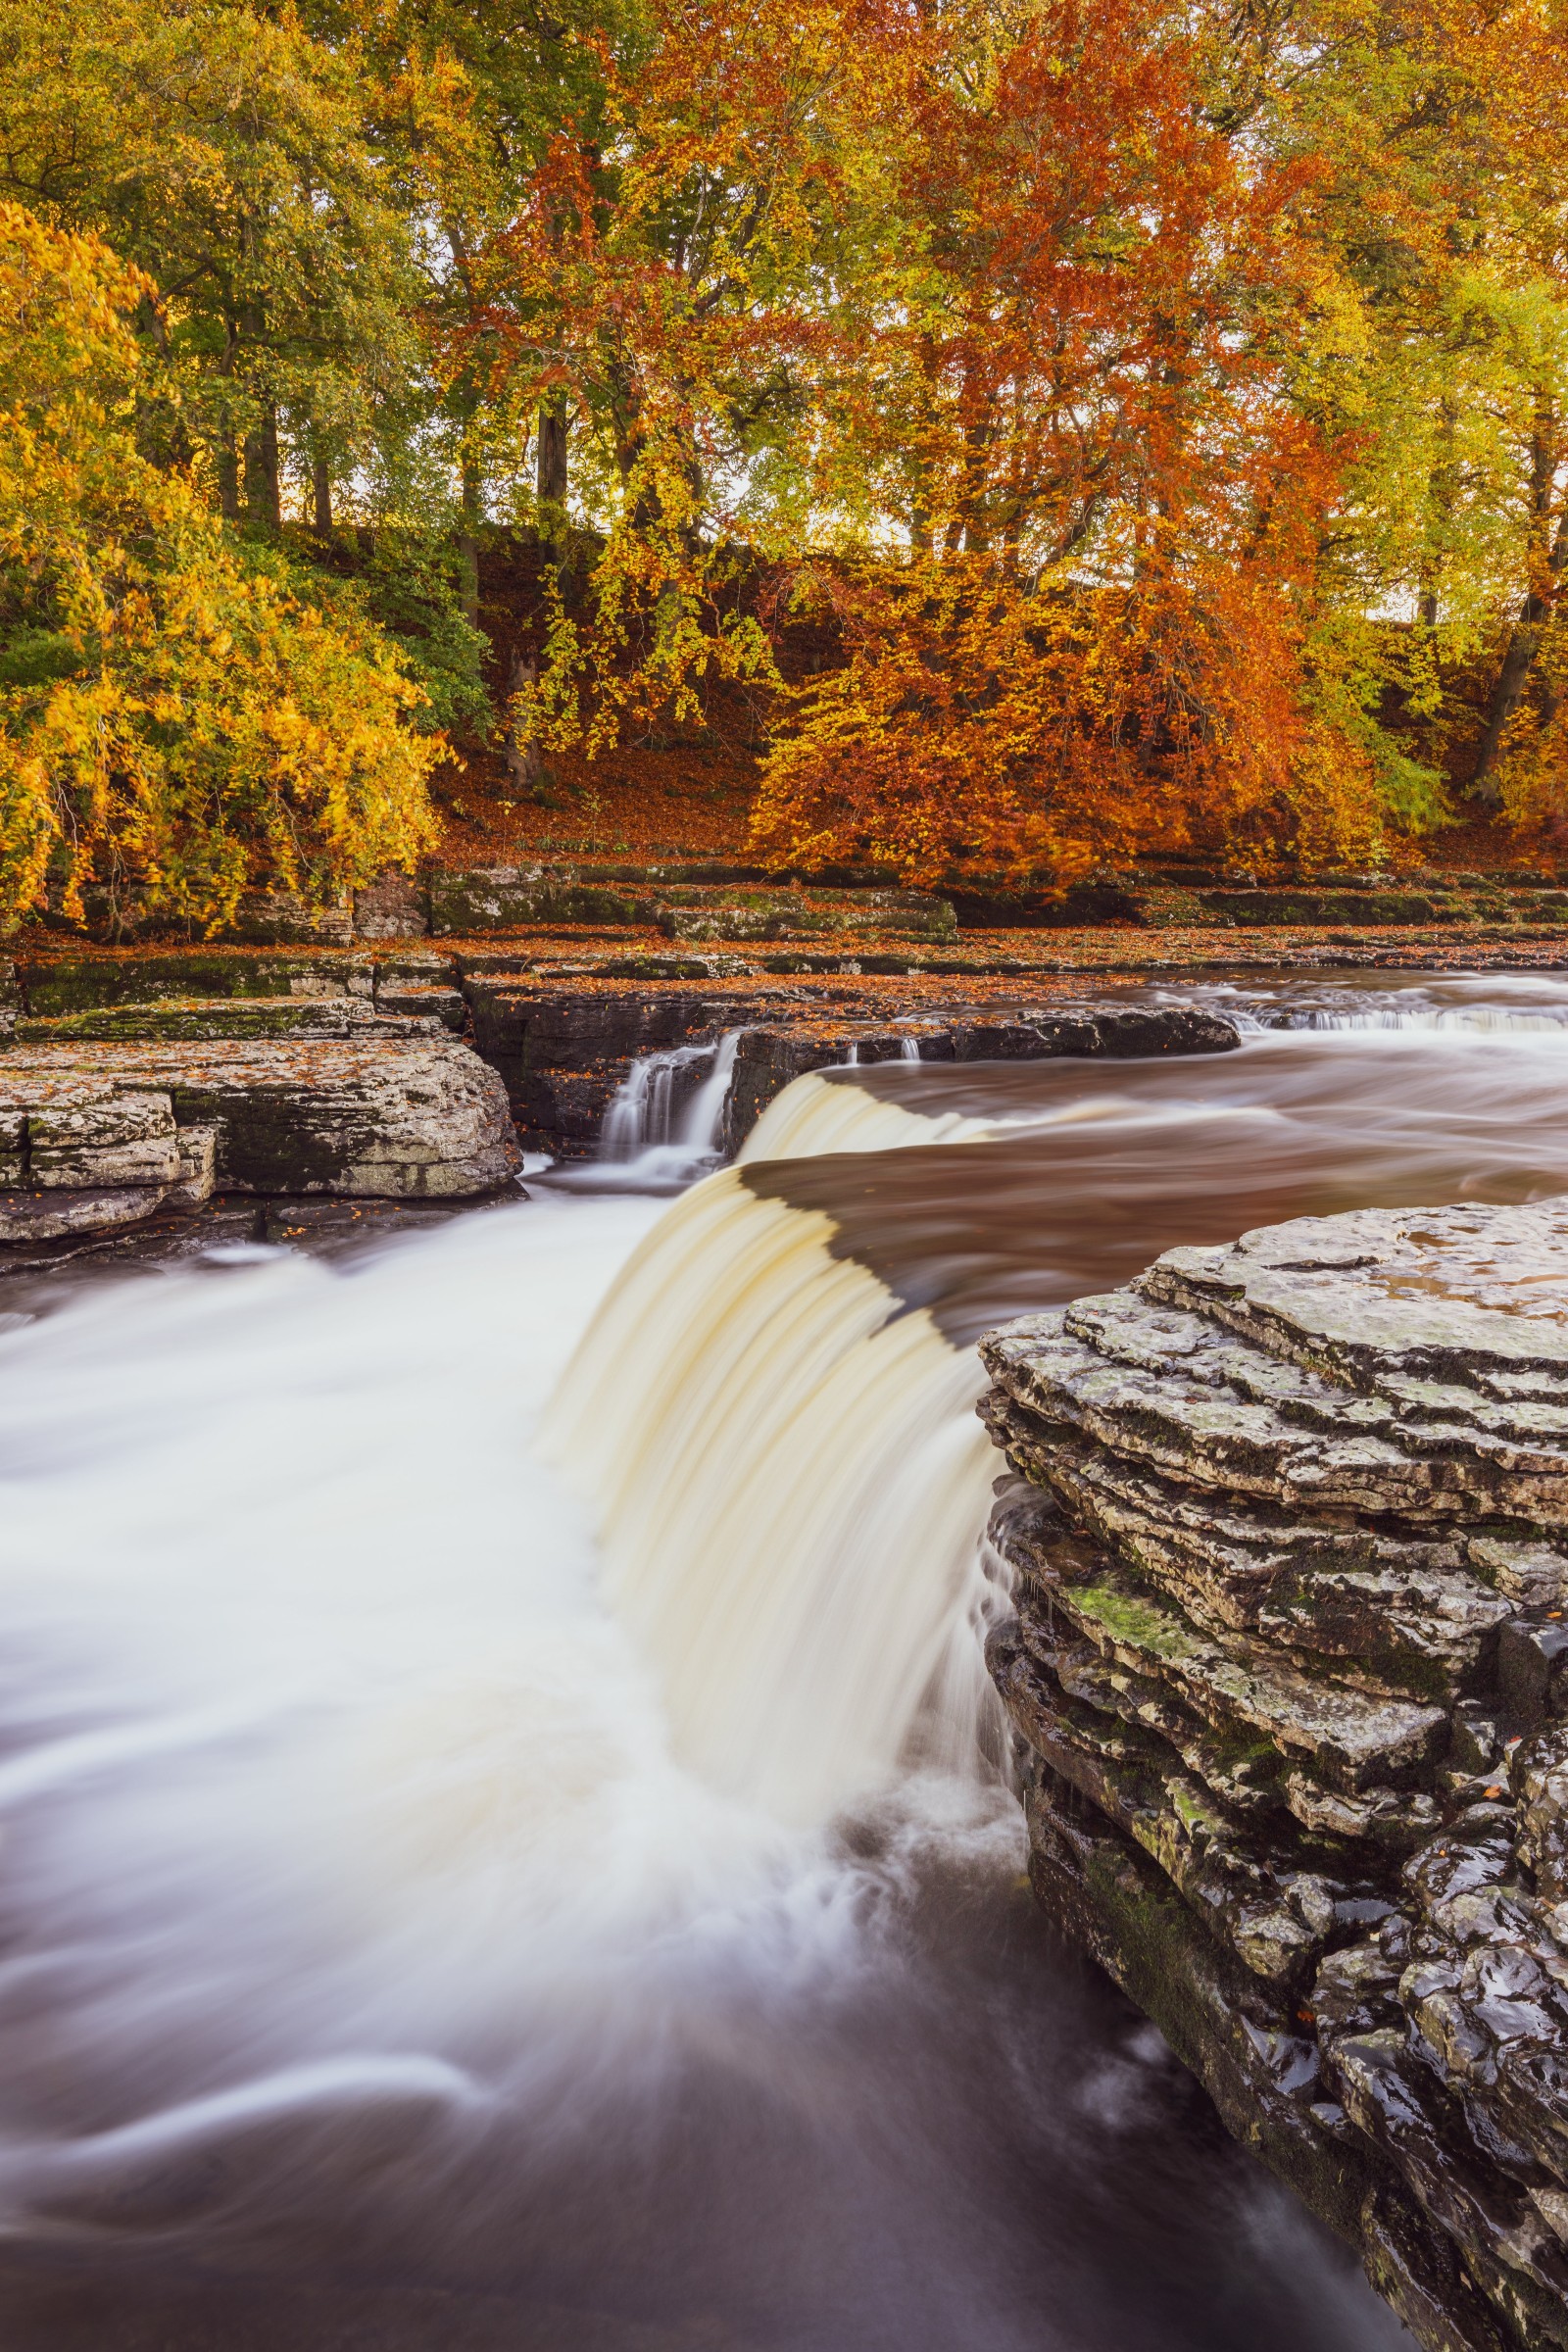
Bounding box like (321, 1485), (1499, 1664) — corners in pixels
(0, 0), (1568, 924)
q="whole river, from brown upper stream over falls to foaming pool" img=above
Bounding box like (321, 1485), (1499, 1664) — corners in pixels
(0, 978), (1568, 2352)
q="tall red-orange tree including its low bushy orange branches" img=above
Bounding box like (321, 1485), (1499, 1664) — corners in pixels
(755, 0), (1375, 880)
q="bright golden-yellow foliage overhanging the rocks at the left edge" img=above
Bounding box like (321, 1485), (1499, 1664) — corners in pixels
(0, 205), (447, 929)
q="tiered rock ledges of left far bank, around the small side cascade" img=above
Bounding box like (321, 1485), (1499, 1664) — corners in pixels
(0, 921), (1237, 1245)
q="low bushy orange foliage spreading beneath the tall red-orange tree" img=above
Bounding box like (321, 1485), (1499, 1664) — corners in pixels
(753, 555), (1368, 882)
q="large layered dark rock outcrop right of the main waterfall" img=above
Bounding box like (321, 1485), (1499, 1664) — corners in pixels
(983, 1201), (1568, 2352)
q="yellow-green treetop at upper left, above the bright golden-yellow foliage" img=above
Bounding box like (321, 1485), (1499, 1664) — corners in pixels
(0, 0), (420, 529)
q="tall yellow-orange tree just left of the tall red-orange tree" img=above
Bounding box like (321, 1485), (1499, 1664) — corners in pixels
(461, 0), (879, 755)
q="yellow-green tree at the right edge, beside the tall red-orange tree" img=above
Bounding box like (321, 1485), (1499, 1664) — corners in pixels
(1203, 0), (1568, 816)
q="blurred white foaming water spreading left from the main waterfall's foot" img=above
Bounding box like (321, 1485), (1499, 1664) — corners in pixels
(0, 1201), (958, 2216)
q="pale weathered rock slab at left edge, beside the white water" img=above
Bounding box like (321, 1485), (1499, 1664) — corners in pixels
(0, 1037), (517, 1200)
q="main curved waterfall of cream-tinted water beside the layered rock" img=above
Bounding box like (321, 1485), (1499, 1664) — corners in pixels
(543, 1171), (997, 1823)
